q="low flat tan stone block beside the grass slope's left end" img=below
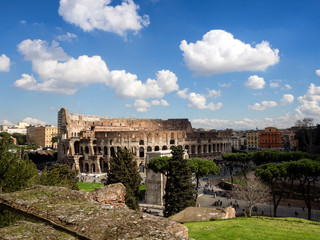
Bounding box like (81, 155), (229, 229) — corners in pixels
(170, 207), (236, 223)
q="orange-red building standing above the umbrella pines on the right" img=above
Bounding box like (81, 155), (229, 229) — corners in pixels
(259, 127), (282, 149)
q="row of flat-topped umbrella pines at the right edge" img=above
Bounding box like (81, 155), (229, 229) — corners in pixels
(223, 150), (320, 219)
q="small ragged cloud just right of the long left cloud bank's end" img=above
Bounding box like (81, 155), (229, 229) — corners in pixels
(177, 88), (222, 111)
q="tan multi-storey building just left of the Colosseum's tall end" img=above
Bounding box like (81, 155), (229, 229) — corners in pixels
(27, 125), (58, 148)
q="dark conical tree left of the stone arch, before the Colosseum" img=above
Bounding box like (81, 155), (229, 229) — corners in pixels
(107, 148), (141, 210)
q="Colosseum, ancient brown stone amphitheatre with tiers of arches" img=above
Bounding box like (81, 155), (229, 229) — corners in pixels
(58, 108), (231, 174)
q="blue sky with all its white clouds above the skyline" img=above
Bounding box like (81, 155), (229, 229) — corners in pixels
(0, 0), (320, 129)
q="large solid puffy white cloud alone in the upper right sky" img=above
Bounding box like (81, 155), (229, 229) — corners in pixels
(180, 30), (279, 76)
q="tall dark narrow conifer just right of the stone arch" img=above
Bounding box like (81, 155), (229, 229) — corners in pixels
(164, 146), (195, 217)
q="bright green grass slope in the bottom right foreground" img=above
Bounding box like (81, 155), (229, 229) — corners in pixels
(184, 217), (320, 240)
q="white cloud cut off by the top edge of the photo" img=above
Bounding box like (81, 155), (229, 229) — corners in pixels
(59, 0), (150, 36)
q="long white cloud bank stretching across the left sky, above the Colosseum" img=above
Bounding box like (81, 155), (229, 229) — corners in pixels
(14, 39), (179, 99)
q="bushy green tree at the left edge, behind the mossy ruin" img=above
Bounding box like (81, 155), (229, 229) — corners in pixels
(0, 137), (38, 192)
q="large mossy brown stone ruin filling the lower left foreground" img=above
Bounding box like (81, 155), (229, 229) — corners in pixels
(0, 186), (188, 240)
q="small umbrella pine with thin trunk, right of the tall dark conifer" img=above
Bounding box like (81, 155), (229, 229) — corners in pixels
(187, 158), (220, 201)
